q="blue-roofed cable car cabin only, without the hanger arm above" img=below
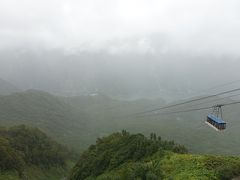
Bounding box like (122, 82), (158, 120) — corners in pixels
(206, 114), (226, 130)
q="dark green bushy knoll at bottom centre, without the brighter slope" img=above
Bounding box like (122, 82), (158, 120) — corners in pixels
(70, 131), (187, 179)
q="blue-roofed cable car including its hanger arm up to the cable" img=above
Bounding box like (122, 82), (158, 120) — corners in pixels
(206, 104), (226, 131)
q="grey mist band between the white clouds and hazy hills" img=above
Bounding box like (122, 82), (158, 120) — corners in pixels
(0, 49), (240, 101)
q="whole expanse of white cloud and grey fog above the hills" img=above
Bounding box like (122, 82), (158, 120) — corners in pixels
(0, 0), (240, 100)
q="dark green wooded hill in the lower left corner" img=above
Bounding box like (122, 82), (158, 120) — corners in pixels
(0, 125), (74, 179)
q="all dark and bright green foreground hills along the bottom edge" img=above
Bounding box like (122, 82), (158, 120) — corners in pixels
(0, 125), (240, 180)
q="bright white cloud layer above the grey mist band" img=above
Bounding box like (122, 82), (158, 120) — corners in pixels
(0, 0), (240, 56)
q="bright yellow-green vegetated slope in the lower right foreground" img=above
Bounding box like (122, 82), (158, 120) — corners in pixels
(94, 152), (240, 180)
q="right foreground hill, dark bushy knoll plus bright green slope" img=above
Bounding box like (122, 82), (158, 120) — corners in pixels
(69, 131), (240, 180)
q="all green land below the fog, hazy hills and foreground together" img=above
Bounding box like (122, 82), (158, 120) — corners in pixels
(0, 90), (240, 180)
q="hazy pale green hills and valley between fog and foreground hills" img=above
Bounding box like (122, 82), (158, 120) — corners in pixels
(0, 90), (240, 155)
